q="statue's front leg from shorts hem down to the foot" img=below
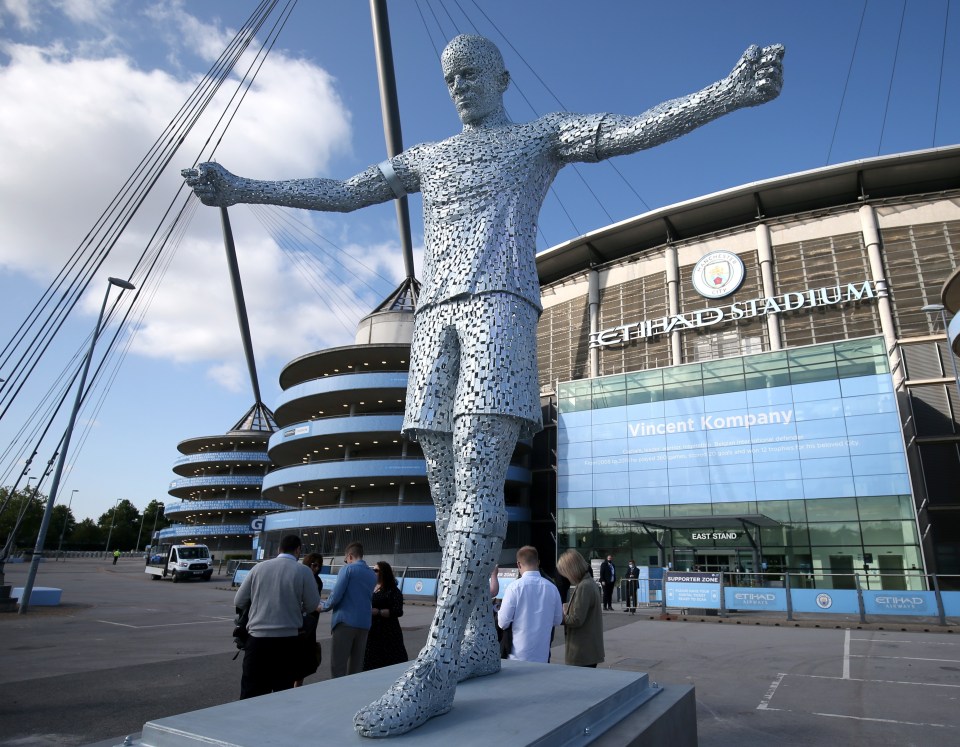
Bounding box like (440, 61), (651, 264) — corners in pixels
(354, 415), (520, 737)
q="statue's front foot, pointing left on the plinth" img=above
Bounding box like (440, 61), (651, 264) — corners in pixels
(353, 649), (457, 737)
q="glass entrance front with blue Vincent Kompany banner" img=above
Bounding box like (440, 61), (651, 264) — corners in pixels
(557, 337), (922, 588)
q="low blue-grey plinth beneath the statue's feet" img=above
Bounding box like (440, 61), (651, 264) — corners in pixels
(127, 661), (697, 747)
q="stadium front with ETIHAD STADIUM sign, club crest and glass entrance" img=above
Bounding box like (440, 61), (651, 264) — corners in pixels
(538, 147), (960, 588)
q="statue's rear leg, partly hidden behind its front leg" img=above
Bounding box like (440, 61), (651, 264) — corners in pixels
(418, 431), (509, 682)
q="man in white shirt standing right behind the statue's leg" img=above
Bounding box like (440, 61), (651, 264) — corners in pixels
(497, 545), (563, 664)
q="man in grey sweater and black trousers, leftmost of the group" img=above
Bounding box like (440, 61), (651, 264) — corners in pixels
(233, 534), (320, 700)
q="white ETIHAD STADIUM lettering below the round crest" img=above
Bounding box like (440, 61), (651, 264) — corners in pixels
(590, 280), (877, 348)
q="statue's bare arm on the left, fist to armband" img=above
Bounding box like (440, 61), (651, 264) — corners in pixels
(180, 163), (396, 213)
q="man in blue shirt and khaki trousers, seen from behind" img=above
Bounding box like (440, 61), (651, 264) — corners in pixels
(320, 542), (377, 677)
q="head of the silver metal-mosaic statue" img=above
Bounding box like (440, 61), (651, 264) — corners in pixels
(440, 34), (510, 125)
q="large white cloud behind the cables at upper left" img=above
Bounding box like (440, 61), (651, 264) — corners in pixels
(0, 10), (408, 388)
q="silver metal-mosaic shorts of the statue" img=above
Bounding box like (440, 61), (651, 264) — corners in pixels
(403, 292), (542, 438)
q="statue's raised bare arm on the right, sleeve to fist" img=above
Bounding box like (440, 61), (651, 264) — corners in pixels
(596, 44), (784, 158)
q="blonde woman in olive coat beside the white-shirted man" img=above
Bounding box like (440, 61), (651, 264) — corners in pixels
(557, 550), (603, 667)
